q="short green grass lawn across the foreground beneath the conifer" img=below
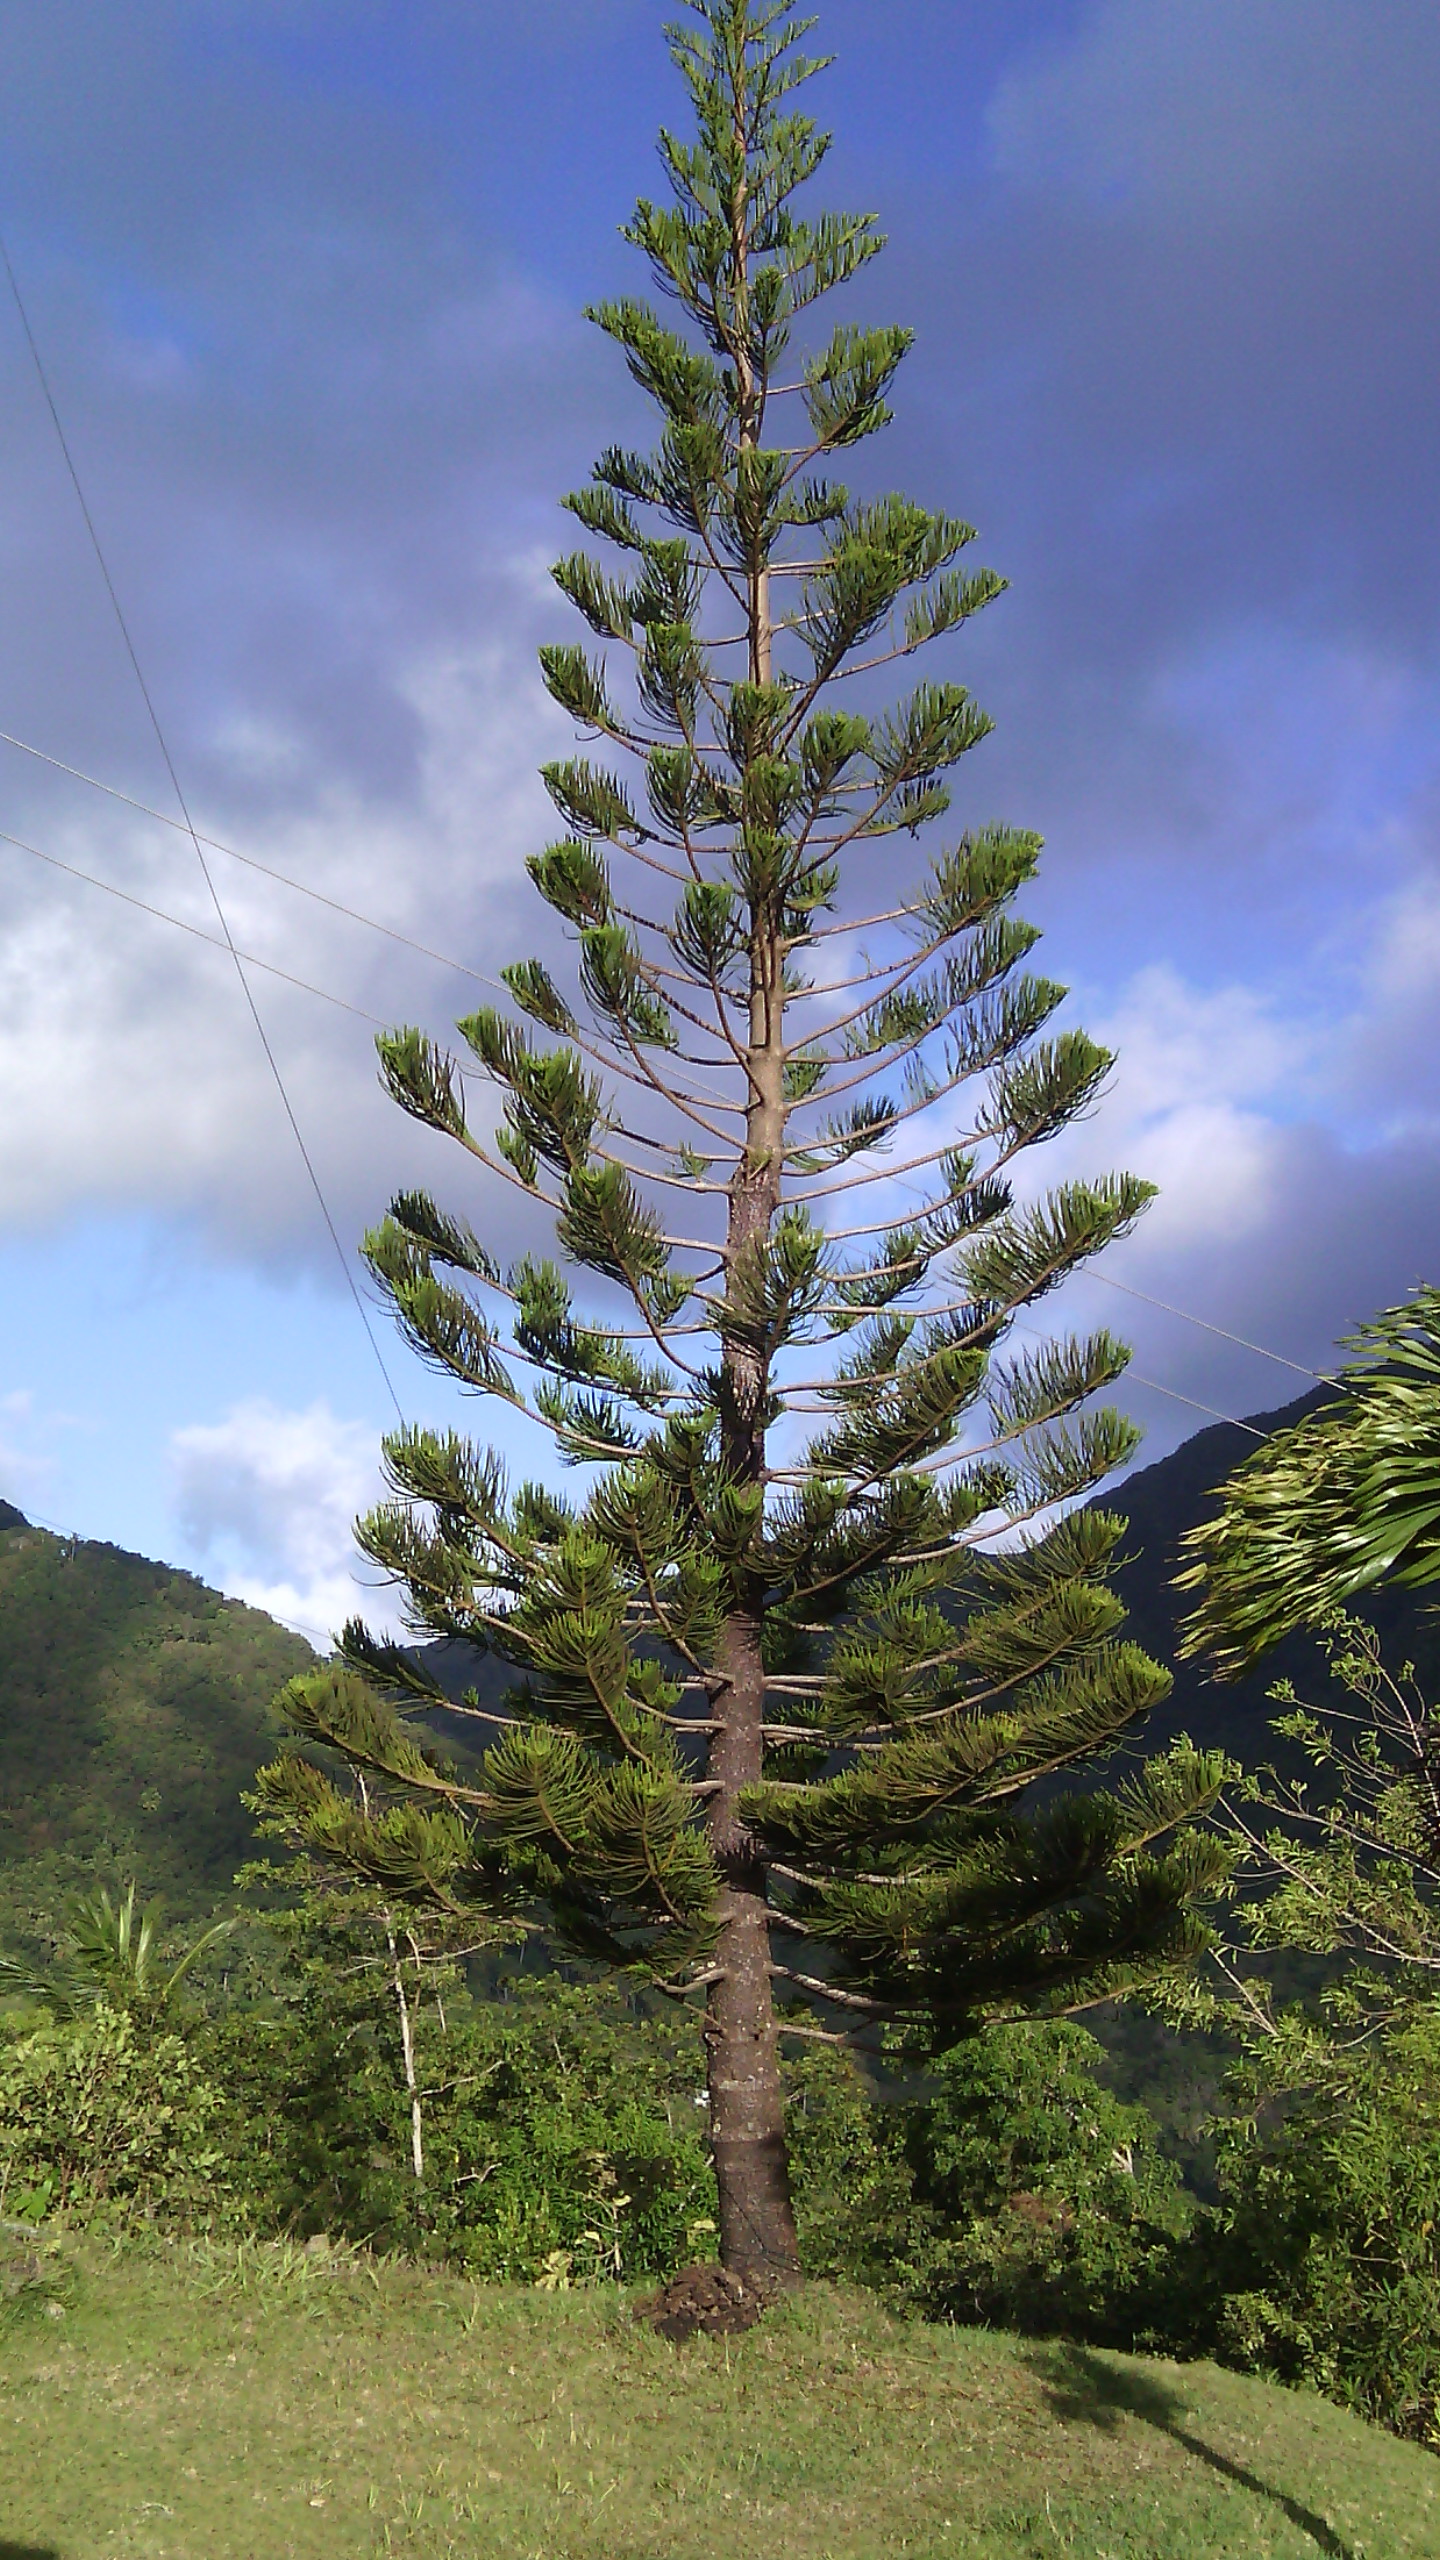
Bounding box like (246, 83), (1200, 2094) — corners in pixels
(0, 2245), (1440, 2560)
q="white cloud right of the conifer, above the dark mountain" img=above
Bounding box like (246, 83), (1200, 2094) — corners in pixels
(1048, 931), (1440, 1454)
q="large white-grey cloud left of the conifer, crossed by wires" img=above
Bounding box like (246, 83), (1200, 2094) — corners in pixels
(0, 624), (556, 1262)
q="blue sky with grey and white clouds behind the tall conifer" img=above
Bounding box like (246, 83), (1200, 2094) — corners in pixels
(0, 0), (1440, 1626)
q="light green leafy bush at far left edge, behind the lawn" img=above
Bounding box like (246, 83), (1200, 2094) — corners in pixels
(0, 2004), (233, 2222)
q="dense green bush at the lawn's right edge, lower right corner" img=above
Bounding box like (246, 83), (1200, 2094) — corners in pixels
(1189, 2012), (1440, 2445)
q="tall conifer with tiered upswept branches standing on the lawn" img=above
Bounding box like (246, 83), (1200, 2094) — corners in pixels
(264, 0), (1222, 2289)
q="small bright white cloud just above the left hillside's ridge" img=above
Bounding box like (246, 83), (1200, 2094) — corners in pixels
(169, 1398), (395, 1638)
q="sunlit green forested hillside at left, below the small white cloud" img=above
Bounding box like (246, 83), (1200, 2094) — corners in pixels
(0, 1508), (315, 1915)
